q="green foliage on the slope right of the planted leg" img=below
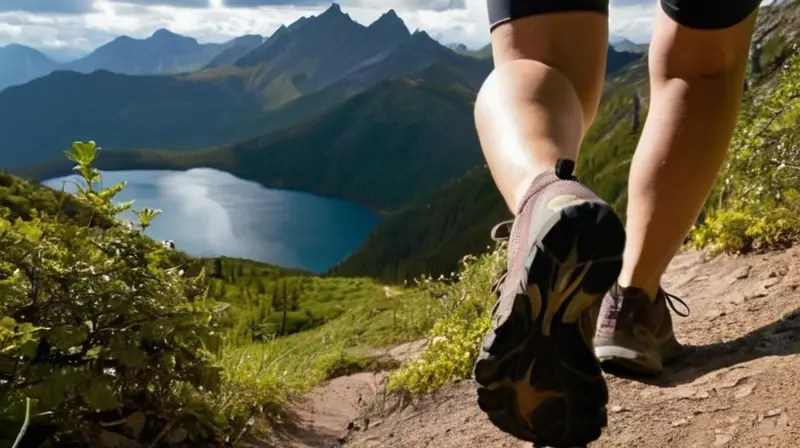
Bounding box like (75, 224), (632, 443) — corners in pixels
(692, 48), (800, 252)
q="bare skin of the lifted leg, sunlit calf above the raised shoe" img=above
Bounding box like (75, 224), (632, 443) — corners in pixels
(475, 9), (608, 213)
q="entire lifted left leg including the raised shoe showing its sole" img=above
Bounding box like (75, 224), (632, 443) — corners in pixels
(475, 0), (625, 446)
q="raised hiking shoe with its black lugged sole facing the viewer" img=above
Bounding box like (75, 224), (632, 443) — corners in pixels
(474, 160), (625, 447)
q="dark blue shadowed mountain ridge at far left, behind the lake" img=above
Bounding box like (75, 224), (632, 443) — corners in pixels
(0, 65), (261, 167)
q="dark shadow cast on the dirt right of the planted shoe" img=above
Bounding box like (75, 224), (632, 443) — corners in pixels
(610, 308), (800, 387)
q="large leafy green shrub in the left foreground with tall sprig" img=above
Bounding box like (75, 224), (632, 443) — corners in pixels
(0, 142), (228, 446)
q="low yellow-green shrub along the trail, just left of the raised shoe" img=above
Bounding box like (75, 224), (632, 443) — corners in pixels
(388, 248), (505, 394)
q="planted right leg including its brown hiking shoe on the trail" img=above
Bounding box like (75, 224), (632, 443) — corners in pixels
(595, 0), (760, 374)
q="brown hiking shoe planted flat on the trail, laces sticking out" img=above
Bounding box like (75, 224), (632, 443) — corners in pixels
(594, 284), (689, 377)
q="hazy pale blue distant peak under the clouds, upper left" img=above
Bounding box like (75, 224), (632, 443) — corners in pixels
(63, 28), (222, 75)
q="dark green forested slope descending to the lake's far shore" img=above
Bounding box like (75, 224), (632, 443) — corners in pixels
(20, 64), (483, 210)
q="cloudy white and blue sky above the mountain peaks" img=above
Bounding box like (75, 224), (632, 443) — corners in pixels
(0, 0), (656, 58)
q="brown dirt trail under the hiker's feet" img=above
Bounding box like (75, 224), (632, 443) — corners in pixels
(255, 247), (800, 448)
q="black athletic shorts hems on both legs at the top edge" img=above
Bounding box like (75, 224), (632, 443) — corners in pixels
(486, 0), (761, 30)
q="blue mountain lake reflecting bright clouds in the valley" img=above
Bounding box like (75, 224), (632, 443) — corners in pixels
(43, 168), (381, 272)
